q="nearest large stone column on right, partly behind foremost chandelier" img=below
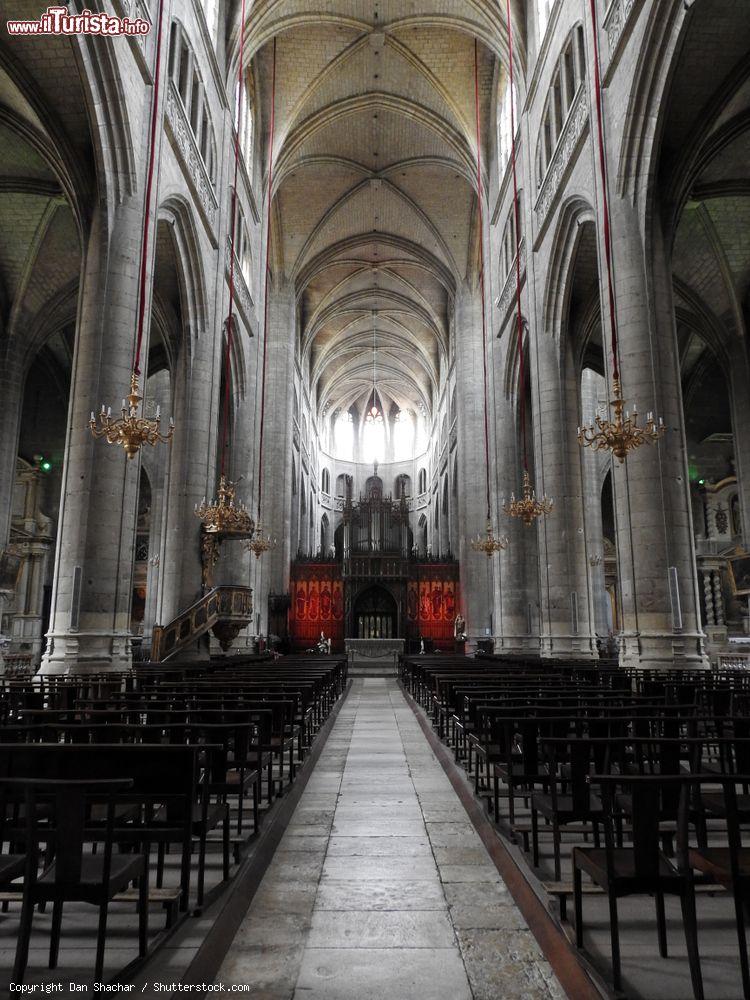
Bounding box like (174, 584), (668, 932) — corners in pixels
(602, 199), (707, 668)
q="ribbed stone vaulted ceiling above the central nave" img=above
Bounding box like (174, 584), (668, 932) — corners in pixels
(249, 0), (504, 415)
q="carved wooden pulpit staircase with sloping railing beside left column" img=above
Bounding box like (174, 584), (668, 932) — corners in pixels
(151, 587), (253, 663)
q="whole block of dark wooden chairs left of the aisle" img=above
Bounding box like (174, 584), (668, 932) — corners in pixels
(0, 657), (347, 983)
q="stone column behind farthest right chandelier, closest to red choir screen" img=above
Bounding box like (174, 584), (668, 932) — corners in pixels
(455, 283), (497, 639)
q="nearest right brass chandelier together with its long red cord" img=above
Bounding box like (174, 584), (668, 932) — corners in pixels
(578, 0), (667, 463)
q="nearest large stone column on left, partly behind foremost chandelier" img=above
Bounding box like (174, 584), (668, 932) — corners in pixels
(41, 201), (147, 673)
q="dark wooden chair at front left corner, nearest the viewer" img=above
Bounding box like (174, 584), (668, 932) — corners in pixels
(3, 778), (148, 983)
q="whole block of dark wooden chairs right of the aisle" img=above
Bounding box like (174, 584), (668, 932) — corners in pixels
(401, 656), (750, 1000)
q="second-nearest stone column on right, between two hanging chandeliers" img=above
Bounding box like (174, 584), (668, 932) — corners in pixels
(531, 325), (596, 658)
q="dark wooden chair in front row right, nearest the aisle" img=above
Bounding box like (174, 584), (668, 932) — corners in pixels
(573, 775), (703, 1000)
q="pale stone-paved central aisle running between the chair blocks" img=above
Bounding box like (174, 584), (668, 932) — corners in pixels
(217, 678), (564, 1000)
